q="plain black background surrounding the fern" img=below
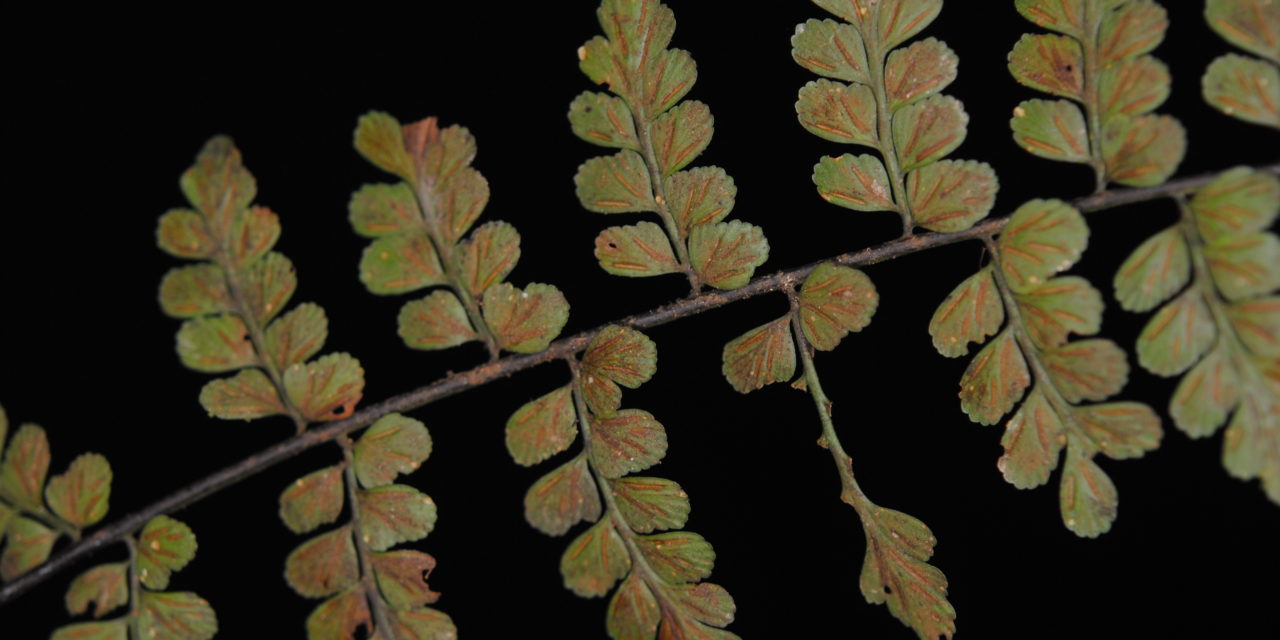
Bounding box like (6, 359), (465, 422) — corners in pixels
(0, 0), (1280, 639)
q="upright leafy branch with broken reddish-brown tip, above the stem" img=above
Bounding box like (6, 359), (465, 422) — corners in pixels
(349, 112), (568, 357)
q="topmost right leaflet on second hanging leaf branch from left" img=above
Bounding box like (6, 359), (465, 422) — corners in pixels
(355, 413), (431, 489)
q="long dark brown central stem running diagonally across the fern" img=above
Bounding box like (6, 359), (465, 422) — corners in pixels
(0, 163), (1280, 604)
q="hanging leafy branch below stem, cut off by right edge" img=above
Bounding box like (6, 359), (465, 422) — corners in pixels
(1115, 166), (1280, 503)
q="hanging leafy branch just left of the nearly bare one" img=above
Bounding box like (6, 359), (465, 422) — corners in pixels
(507, 325), (737, 640)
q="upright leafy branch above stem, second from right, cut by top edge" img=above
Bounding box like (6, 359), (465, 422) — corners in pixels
(1009, 0), (1187, 191)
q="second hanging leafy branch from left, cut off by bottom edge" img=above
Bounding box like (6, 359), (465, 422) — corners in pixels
(280, 413), (457, 640)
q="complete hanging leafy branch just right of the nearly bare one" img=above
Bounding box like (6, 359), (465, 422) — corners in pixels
(929, 200), (1161, 538)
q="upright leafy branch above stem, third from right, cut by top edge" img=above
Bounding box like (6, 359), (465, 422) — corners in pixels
(791, 0), (998, 233)
